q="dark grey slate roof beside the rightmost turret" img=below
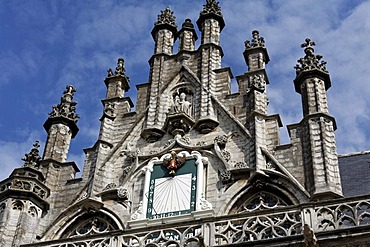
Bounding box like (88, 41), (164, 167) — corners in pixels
(339, 151), (370, 197)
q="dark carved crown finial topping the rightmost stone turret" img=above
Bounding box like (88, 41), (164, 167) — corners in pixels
(294, 38), (328, 75)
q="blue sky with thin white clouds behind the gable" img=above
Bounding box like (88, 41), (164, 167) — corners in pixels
(0, 0), (370, 180)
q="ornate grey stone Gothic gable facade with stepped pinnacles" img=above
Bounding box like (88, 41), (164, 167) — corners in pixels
(0, 0), (370, 247)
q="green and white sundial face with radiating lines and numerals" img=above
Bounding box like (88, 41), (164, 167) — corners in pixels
(146, 159), (197, 219)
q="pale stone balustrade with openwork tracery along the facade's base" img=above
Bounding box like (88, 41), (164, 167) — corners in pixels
(24, 196), (370, 247)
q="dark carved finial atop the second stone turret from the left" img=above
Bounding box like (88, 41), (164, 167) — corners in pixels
(49, 85), (79, 123)
